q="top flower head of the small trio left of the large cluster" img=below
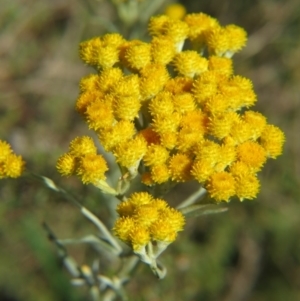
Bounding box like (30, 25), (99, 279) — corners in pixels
(69, 136), (97, 157)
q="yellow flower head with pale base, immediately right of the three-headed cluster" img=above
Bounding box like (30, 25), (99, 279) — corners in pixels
(113, 136), (147, 168)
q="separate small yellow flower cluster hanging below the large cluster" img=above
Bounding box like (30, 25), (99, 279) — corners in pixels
(113, 192), (185, 251)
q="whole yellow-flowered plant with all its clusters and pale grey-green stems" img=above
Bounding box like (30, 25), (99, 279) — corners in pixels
(0, 2), (284, 300)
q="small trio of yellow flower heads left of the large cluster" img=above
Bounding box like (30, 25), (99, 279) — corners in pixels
(56, 136), (108, 184)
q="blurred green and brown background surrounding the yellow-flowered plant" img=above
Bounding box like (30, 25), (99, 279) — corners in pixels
(0, 0), (300, 301)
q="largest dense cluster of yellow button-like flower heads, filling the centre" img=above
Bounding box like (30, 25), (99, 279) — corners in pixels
(58, 13), (285, 204)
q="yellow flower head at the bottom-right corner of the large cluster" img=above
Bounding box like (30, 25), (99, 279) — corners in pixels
(235, 173), (260, 201)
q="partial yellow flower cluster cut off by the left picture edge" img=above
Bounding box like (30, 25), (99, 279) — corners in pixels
(0, 140), (25, 179)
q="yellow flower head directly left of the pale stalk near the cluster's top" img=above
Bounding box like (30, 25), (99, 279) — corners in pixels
(150, 37), (175, 65)
